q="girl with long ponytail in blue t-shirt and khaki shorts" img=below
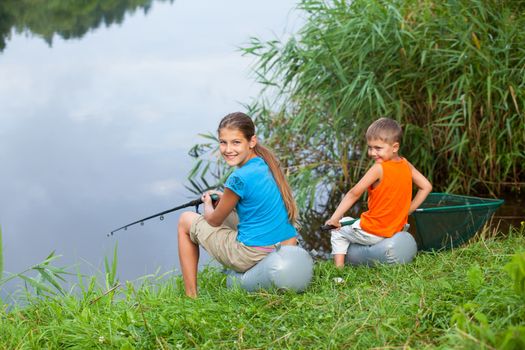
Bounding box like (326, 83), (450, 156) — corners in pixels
(178, 112), (298, 297)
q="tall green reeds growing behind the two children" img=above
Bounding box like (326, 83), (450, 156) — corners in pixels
(238, 0), (525, 208)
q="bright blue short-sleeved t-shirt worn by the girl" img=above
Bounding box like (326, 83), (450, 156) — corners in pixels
(225, 157), (297, 246)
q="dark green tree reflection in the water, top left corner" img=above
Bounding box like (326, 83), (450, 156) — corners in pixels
(0, 0), (174, 51)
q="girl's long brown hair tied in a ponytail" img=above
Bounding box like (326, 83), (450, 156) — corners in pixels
(217, 112), (299, 225)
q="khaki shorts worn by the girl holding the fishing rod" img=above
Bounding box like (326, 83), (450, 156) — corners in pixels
(190, 212), (273, 272)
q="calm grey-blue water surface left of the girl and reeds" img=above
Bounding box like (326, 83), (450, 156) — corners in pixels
(0, 0), (300, 292)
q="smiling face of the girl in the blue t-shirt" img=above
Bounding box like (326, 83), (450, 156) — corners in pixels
(219, 128), (257, 167)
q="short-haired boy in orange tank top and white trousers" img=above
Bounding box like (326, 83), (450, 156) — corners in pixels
(326, 118), (432, 267)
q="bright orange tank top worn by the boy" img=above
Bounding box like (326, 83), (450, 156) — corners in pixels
(361, 158), (412, 237)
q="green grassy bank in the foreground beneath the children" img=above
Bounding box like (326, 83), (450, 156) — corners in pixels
(0, 230), (525, 349)
